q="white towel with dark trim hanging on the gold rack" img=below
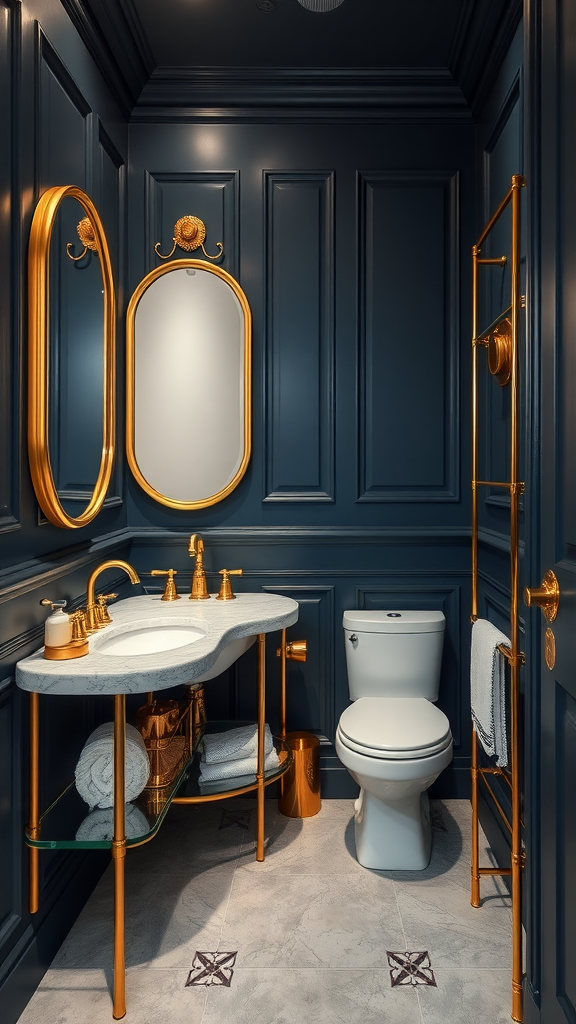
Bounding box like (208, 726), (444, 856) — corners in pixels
(470, 618), (510, 768)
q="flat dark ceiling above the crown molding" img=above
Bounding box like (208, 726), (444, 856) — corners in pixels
(135, 0), (461, 68)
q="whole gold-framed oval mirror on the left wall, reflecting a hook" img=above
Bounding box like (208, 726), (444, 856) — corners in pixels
(28, 185), (116, 529)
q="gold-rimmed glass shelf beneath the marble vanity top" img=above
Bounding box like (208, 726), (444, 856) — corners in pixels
(26, 722), (292, 850)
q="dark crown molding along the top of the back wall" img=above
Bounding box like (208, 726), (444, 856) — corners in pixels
(132, 67), (471, 123)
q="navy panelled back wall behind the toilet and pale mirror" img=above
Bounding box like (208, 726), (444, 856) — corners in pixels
(127, 118), (476, 796)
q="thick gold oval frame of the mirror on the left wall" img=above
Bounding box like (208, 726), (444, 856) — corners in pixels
(28, 185), (116, 529)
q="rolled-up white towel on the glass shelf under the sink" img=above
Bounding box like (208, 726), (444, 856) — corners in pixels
(74, 722), (150, 810)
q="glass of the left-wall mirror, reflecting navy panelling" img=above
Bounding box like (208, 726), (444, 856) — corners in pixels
(48, 197), (105, 515)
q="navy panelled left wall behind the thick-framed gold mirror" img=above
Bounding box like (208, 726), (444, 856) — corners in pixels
(0, 0), (129, 1022)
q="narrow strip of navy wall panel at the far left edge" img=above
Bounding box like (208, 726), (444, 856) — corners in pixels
(0, 0), (23, 534)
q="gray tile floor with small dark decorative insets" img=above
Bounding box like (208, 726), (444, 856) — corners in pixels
(19, 798), (510, 1024)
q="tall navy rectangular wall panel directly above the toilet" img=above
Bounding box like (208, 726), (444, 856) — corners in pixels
(357, 170), (460, 504)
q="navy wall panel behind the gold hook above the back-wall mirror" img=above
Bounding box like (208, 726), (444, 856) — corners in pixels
(143, 170), (240, 278)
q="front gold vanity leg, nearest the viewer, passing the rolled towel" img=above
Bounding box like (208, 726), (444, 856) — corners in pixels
(112, 694), (126, 1020)
